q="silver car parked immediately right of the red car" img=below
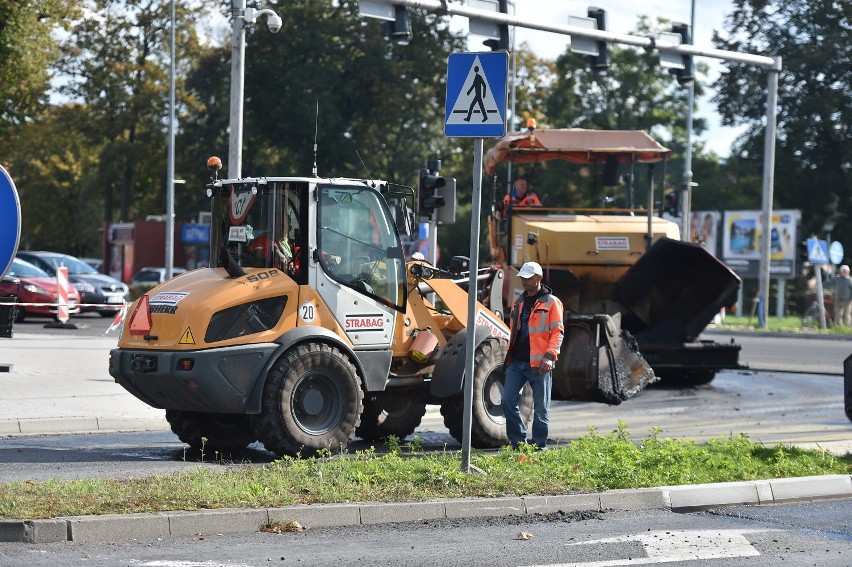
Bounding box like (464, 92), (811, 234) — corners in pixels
(18, 250), (129, 317)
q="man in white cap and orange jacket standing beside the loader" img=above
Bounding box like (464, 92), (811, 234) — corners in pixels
(503, 262), (565, 450)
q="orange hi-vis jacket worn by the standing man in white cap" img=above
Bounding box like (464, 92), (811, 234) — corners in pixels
(505, 285), (565, 368)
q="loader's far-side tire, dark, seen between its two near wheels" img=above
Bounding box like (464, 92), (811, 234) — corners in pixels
(355, 396), (426, 441)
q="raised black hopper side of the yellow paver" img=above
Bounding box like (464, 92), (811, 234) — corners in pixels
(615, 238), (740, 345)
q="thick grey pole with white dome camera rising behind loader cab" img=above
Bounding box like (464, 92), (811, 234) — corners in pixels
(228, 0), (283, 179)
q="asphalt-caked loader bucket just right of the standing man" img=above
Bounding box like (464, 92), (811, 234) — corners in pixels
(552, 313), (657, 405)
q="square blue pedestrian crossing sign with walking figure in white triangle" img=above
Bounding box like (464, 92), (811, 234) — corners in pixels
(444, 51), (509, 138)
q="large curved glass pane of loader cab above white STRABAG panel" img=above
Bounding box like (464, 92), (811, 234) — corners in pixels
(318, 186), (405, 310)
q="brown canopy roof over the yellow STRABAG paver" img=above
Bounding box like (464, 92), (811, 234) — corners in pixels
(483, 128), (672, 175)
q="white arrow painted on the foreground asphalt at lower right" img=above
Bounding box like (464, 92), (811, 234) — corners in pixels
(529, 530), (770, 567)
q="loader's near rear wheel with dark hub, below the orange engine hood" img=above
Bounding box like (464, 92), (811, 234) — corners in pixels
(252, 343), (364, 456)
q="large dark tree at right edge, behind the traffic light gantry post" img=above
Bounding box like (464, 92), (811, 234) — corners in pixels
(713, 0), (852, 244)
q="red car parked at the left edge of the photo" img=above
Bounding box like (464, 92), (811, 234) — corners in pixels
(0, 258), (80, 323)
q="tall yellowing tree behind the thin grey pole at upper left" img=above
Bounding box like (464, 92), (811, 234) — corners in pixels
(61, 0), (204, 226)
